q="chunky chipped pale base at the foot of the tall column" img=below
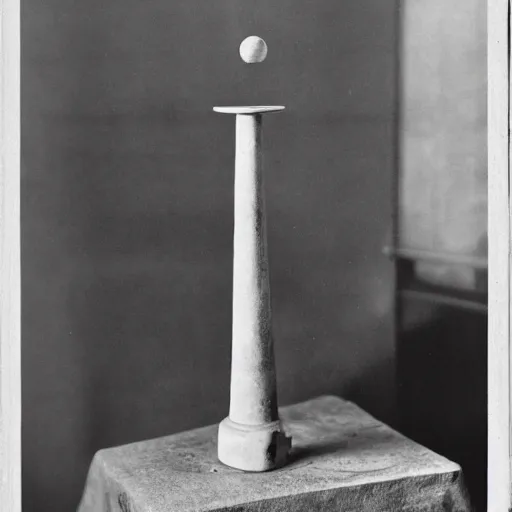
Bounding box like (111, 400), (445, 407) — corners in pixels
(217, 418), (292, 472)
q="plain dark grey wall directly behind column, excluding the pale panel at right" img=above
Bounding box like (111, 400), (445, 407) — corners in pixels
(22, 0), (396, 512)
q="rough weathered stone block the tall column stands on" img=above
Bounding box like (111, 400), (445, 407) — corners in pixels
(78, 396), (470, 512)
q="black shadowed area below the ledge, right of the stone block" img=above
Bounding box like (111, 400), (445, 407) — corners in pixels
(397, 300), (487, 512)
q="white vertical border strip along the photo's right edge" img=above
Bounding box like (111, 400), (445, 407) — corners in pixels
(487, 0), (512, 512)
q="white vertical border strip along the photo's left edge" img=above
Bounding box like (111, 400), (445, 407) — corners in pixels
(0, 0), (21, 512)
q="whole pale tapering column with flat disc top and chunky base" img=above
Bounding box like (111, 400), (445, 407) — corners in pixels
(214, 106), (291, 471)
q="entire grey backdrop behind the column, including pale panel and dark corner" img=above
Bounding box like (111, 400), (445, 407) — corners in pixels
(21, 0), (486, 512)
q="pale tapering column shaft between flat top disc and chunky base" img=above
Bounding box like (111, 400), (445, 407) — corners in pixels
(230, 114), (278, 425)
